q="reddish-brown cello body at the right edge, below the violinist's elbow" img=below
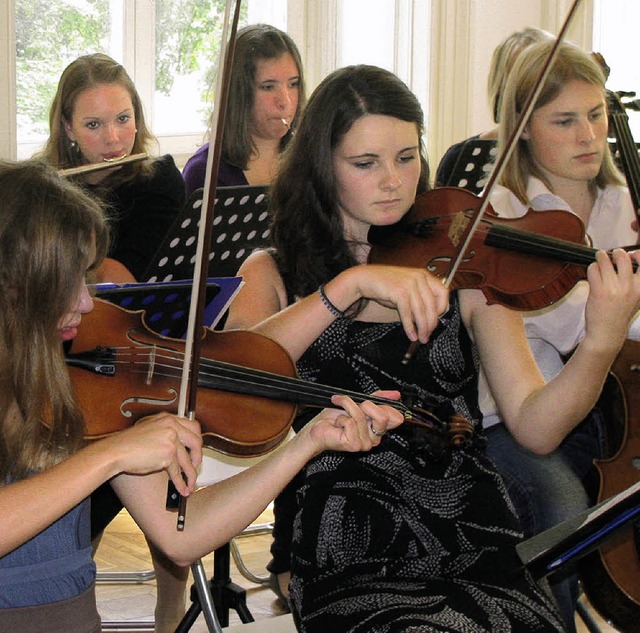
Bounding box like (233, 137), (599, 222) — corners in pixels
(580, 340), (640, 633)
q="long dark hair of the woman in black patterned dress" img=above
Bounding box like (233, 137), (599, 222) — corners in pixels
(269, 65), (429, 296)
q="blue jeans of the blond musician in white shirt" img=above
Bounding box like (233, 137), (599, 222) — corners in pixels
(487, 419), (600, 632)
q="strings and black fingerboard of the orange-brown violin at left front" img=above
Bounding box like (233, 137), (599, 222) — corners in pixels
(104, 346), (446, 431)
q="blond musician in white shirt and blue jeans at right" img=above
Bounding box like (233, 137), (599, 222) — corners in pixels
(481, 42), (640, 630)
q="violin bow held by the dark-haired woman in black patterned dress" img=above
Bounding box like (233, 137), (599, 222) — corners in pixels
(444, 0), (580, 287)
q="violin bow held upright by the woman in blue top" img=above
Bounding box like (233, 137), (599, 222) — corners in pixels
(167, 0), (242, 532)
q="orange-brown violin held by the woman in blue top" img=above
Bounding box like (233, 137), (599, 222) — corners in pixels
(67, 299), (471, 457)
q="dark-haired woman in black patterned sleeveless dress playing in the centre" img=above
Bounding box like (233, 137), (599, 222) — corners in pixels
(222, 66), (640, 633)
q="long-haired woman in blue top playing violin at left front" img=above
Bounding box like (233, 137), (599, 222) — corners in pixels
(0, 157), (403, 633)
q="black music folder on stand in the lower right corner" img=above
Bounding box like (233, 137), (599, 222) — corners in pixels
(516, 482), (640, 578)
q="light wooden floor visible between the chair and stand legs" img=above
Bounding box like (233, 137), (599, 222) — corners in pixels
(96, 510), (616, 633)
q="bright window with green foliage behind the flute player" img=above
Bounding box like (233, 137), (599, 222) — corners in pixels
(14, 0), (286, 158)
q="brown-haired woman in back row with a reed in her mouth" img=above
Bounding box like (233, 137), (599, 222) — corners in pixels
(182, 24), (306, 195)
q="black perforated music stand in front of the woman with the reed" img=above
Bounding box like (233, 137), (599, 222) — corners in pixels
(143, 185), (269, 281)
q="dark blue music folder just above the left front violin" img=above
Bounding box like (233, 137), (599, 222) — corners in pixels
(95, 277), (242, 338)
